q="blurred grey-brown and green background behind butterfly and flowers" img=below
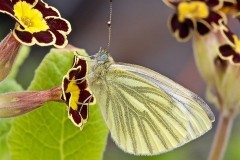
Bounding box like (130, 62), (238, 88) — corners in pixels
(0, 0), (240, 160)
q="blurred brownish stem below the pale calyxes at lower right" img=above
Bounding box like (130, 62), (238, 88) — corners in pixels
(208, 112), (234, 160)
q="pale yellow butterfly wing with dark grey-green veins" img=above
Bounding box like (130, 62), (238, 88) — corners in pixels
(92, 64), (214, 155)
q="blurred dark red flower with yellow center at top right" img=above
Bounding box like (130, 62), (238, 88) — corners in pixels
(164, 0), (226, 41)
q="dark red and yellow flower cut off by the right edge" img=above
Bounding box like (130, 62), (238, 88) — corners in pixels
(219, 24), (240, 64)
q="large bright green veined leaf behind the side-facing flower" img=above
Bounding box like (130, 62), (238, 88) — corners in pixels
(9, 49), (108, 160)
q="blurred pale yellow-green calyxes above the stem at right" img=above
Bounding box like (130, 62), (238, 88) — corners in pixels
(193, 31), (240, 114)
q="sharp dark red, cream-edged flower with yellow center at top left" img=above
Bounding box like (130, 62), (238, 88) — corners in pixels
(0, 0), (71, 48)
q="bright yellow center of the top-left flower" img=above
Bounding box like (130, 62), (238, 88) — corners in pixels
(13, 1), (49, 33)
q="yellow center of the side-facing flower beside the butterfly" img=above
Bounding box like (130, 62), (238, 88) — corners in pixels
(66, 78), (80, 110)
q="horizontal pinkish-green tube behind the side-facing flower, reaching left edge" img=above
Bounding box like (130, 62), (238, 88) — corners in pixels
(0, 87), (62, 118)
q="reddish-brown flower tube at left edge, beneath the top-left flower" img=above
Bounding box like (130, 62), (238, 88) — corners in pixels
(0, 32), (21, 81)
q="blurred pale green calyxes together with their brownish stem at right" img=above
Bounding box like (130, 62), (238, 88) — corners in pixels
(193, 30), (240, 160)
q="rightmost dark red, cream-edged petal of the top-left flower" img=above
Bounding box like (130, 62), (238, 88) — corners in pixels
(46, 17), (71, 33)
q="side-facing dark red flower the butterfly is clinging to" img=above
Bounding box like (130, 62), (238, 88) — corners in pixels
(61, 55), (95, 129)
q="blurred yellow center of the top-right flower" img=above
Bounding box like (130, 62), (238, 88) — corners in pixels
(178, 1), (209, 22)
